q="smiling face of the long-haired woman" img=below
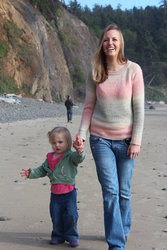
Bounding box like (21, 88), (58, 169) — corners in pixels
(103, 30), (121, 58)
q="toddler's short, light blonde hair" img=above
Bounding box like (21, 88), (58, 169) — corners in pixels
(48, 127), (72, 150)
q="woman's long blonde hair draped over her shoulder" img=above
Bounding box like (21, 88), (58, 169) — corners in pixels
(92, 23), (127, 83)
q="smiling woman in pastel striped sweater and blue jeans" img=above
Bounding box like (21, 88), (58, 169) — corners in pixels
(75, 24), (144, 250)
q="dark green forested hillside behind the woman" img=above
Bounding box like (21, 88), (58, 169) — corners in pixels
(67, 0), (167, 101)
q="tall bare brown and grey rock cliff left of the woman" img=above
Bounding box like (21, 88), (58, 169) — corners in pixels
(0, 0), (96, 102)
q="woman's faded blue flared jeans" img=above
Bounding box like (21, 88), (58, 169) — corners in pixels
(90, 135), (134, 250)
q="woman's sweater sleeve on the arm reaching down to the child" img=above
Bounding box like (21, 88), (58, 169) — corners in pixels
(79, 73), (96, 140)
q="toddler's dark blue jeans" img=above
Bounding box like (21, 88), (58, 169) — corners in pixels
(50, 189), (79, 242)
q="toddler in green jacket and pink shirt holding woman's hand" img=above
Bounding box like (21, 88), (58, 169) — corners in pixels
(21, 127), (85, 247)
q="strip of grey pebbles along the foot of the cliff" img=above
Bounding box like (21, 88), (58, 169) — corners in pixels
(0, 97), (82, 123)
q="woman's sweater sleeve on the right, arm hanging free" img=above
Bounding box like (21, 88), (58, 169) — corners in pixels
(131, 64), (144, 145)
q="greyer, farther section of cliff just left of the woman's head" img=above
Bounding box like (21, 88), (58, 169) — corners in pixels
(57, 9), (97, 98)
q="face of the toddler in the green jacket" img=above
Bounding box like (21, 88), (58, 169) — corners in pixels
(51, 133), (68, 155)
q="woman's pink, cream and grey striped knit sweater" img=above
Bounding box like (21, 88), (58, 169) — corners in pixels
(79, 61), (144, 145)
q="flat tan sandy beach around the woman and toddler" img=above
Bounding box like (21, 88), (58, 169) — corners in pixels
(0, 107), (167, 250)
